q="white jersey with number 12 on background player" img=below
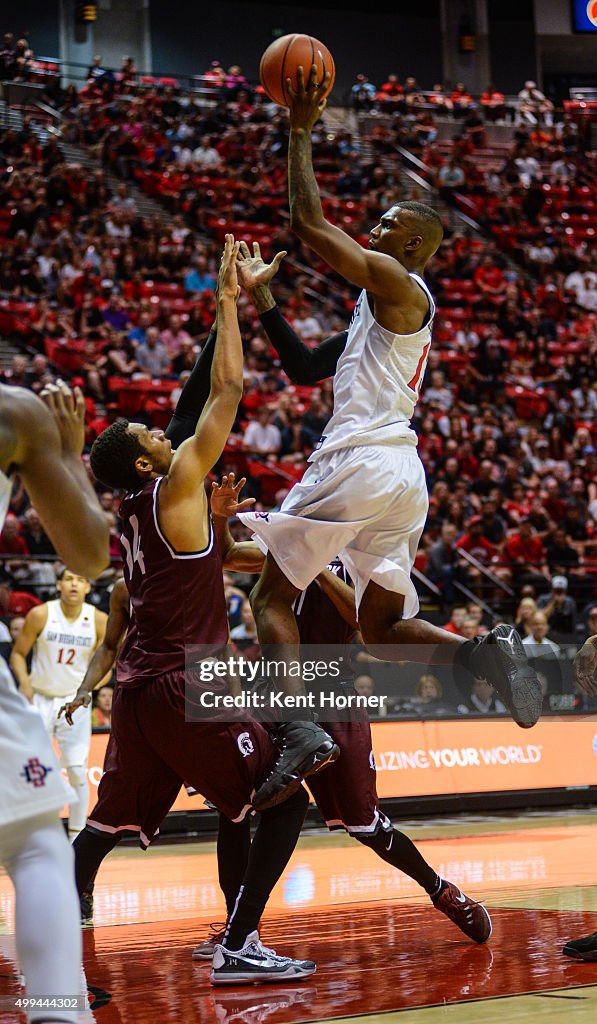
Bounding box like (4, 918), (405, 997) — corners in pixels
(31, 600), (97, 697)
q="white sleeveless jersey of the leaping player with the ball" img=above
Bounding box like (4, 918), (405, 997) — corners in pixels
(309, 273), (435, 462)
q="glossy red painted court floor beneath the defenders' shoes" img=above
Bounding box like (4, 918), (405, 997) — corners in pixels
(0, 903), (597, 1024)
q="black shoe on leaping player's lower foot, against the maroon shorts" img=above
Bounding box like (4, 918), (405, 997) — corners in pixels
(253, 722), (340, 811)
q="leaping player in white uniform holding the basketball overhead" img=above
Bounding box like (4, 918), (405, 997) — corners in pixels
(239, 67), (542, 810)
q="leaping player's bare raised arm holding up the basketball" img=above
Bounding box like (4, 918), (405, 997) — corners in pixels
(287, 66), (418, 305)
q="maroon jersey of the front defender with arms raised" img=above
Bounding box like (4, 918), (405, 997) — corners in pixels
(117, 477), (228, 686)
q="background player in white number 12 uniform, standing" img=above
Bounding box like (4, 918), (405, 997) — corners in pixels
(10, 569), (108, 843)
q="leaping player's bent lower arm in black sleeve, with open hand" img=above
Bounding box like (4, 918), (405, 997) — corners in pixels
(238, 242), (348, 385)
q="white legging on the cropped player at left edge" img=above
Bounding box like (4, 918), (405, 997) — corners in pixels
(2, 812), (81, 1022)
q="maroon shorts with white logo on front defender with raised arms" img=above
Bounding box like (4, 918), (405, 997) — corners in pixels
(88, 672), (276, 847)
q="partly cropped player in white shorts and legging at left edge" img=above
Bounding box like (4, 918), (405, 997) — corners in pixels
(0, 385), (109, 1024)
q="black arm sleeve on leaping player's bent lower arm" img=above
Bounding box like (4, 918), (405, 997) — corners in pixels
(259, 306), (348, 384)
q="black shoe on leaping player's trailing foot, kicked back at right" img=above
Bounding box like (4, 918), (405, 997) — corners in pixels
(469, 623), (543, 729)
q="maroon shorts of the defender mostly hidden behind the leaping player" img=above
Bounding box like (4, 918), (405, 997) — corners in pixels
(305, 719), (390, 835)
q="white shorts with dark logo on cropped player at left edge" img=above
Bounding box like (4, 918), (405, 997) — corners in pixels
(0, 657), (69, 827)
